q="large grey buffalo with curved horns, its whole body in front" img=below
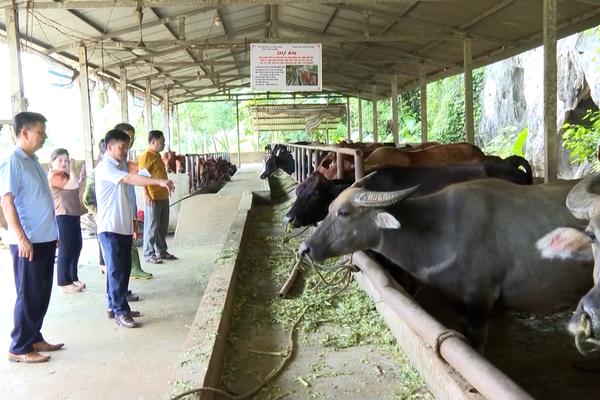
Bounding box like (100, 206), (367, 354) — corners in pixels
(299, 179), (592, 346)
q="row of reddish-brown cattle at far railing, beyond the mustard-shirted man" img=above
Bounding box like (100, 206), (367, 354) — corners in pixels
(162, 151), (237, 192)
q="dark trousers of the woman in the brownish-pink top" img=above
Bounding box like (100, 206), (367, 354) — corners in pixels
(56, 215), (83, 286)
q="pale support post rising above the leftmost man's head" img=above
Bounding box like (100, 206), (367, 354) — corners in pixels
(4, 6), (27, 115)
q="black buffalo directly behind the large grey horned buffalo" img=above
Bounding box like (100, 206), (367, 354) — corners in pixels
(285, 156), (532, 227)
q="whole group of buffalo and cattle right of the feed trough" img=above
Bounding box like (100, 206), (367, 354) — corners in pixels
(261, 143), (600, 354)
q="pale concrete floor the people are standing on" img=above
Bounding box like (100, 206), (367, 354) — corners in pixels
(0, 166), (263, 400)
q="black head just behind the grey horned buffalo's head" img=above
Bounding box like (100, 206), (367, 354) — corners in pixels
(285, 172), (350, 228)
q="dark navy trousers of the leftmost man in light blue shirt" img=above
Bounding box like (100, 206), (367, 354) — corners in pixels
(10, 241), (56, 354)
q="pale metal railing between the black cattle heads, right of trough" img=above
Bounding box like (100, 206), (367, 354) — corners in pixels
(272, 144), (365, 183)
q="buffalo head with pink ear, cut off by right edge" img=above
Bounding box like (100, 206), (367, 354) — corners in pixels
(537, 174), (600, 348)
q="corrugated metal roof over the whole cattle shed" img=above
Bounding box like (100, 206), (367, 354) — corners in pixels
(0, 0), (600, 102)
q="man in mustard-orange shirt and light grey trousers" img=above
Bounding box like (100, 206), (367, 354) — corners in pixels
(139, 130), (177, 264)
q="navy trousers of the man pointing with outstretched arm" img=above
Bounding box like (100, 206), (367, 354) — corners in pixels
(98, 232), (133, 315)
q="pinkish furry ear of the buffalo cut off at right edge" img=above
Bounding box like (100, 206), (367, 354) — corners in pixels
(536, 228), (594, 262)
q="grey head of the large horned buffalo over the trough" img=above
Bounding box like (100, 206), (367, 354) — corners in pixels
(299, 176), (419, 261)
